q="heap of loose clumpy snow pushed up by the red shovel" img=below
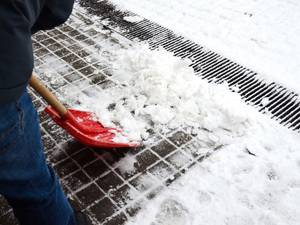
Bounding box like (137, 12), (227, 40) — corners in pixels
(62, 45), (252, 141)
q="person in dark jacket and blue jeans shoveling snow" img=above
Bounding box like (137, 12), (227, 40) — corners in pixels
(0, 0), (88, 225)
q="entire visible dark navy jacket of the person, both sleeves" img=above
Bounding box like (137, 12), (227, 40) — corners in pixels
(0, 0), (74, 103)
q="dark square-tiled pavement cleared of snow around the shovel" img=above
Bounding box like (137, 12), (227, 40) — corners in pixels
(0, 6), (216, 225)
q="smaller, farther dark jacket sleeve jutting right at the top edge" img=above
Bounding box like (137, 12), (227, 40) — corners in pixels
(32, 0), (74, 33)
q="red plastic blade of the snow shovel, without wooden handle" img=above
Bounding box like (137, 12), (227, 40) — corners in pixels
(45, 106), (139, 148)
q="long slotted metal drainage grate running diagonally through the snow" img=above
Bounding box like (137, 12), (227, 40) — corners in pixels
(77, 0), (300, 132)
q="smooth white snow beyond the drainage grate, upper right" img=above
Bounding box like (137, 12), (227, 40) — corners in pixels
(110, 0), (300, 93)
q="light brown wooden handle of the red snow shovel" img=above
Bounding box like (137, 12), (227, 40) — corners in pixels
(29, 75), (68, 118)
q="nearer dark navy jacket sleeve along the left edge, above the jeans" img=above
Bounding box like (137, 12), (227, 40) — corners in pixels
(0, 0), (34, 104)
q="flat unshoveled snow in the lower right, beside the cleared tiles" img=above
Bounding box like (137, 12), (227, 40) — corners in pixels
(126, 120), (300, 225)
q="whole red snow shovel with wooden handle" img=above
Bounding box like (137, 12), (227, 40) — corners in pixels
(29, 75), (139, 148)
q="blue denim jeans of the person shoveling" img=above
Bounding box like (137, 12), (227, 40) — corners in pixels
(0, 92), (76, 225)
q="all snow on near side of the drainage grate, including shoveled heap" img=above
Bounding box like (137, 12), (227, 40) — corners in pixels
(55, 37), (300, 225)
